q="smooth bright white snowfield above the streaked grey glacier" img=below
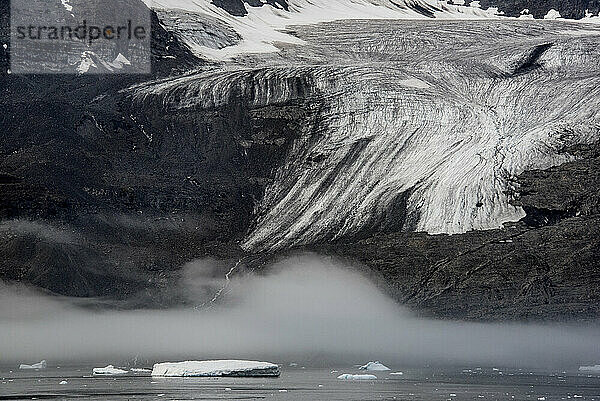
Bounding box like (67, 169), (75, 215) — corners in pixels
(147, 0), (498, 60)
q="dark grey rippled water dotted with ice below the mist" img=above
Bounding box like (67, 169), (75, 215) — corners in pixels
(0, 366), (600, 401)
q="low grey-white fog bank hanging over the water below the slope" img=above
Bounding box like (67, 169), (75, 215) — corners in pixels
(0, 255), (600, 367)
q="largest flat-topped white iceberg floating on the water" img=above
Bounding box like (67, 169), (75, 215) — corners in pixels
(152, 360), (279, 377)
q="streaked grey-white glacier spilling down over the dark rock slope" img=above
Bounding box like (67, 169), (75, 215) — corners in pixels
(131, 21), (600, 250)
